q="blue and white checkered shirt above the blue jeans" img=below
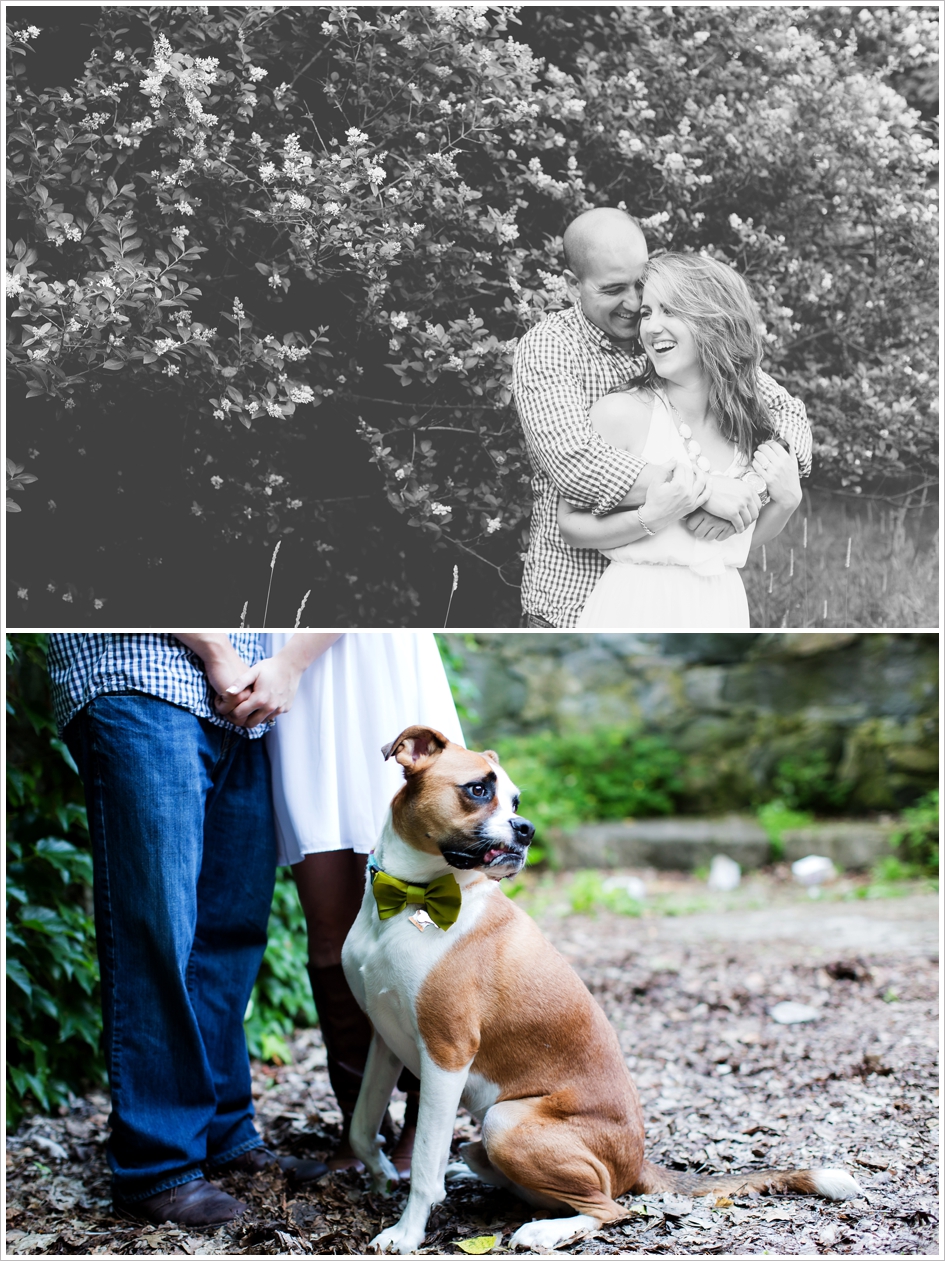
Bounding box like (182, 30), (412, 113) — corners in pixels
(47, 631), (267, 740)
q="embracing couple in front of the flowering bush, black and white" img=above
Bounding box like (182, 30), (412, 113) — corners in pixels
(512, 207), (811, 629)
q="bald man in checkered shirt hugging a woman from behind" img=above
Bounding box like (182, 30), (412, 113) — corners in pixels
(512, 207), (811, 628)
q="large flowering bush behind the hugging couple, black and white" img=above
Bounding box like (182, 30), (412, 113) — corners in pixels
(6, 5), (937, 620)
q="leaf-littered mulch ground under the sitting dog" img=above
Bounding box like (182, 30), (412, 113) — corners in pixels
(6, 882), (941, 1256)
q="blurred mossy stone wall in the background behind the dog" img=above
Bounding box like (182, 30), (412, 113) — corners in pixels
(453, 632), (939, 813)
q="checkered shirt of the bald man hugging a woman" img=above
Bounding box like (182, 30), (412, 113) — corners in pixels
(512, 304), (811, 628)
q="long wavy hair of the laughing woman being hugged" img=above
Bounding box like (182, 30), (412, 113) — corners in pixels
(628, 253), (775, 459)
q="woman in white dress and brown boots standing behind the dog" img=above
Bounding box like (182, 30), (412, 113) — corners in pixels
(230, 631), (466, 1174)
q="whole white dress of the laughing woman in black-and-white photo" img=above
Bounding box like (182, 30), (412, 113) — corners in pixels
(578, 395), (754, 631)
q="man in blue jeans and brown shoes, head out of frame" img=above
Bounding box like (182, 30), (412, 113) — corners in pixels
(48, 632), (327, 1226)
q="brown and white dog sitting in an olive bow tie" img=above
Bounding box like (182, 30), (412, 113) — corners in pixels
(342, 726), (862, 1253)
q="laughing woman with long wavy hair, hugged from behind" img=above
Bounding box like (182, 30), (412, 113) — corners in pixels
(558, 255), (801, 629)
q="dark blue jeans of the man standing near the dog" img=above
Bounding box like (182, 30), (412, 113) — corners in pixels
(66, 694), (275, 1203)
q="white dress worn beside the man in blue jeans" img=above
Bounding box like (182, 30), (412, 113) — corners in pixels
(264, 631), (466, 864)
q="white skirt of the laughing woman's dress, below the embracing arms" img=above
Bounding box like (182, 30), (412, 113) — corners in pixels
(578, 561), (749, 631)
